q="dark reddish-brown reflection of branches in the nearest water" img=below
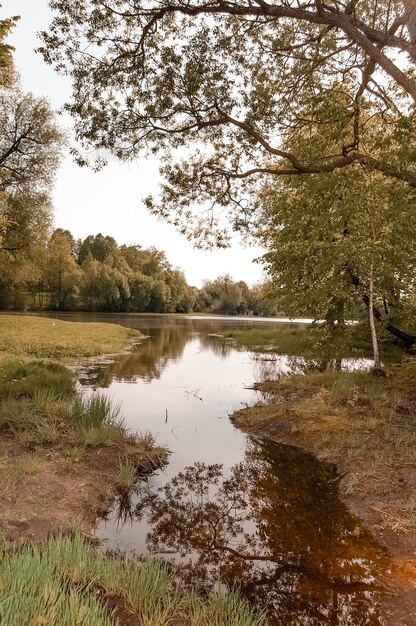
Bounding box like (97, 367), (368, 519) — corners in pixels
(136, 443), (388, 626)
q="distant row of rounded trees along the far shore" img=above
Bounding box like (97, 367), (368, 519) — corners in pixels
(0, 228), (277, 315)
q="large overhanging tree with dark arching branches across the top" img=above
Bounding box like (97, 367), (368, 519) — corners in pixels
(43, 0), (416, 245)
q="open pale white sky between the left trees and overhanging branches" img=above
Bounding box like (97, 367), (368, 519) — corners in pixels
(0, 0), (262, 287)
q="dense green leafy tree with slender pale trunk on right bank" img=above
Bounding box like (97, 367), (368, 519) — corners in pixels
(259, 166), (416, 354)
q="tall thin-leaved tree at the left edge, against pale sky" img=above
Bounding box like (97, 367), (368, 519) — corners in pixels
(0, 70), (64, 298)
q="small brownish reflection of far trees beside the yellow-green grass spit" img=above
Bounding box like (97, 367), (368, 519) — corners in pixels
(79, 326), (189, 387)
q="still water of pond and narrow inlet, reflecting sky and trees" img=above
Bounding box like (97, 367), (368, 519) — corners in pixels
(47, 315), (389, 626)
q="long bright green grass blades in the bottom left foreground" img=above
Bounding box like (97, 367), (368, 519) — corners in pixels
(0, 535), (265, 626)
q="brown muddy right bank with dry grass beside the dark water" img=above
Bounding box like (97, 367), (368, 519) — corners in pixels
(231, 363), (416, 626)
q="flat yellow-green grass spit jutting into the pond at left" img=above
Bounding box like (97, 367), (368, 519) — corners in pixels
(0, 315), (140, 361)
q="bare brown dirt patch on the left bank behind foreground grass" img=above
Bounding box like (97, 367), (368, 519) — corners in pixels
(0, 437), (158, 542)
